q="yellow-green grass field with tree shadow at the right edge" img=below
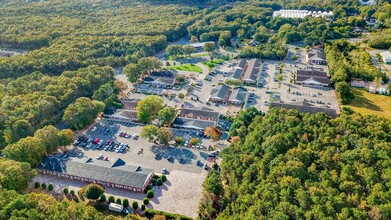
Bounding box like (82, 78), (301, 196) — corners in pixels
(348, 88), (391, 119)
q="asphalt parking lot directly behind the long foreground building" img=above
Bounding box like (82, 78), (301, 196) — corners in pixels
(73, 119), (219, 173)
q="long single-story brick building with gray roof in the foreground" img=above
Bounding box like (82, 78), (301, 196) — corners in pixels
(38, 154), (154, 192)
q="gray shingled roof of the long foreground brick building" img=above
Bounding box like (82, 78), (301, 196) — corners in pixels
(38, 156), (153, 189)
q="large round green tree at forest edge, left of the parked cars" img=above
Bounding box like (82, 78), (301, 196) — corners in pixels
(63, 97), (105, 130)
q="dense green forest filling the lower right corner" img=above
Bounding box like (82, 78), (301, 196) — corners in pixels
(200, 109), (391, 219)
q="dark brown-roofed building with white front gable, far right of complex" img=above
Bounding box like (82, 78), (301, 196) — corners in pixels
(296, 70), (330, 87)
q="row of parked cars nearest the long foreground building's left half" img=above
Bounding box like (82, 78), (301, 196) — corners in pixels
(73, 136), (129, 153)
